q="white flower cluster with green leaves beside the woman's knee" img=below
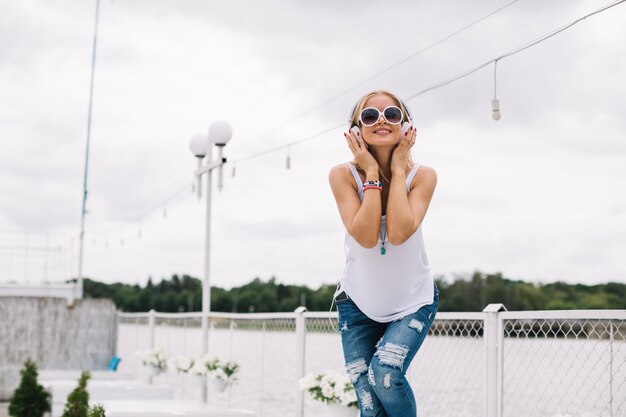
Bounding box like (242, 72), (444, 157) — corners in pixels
(298, 371), (359, 408)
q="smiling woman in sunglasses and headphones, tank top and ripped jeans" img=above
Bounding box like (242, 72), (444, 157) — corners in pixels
(329, 91), (438, 417)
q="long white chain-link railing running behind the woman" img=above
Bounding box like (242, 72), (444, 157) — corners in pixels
(117, 305), (626, 417)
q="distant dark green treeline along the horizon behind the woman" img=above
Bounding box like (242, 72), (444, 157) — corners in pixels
(84, 272), (626, 313)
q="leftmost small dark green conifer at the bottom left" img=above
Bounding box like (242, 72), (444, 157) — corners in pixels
(9, 359), (51, 417)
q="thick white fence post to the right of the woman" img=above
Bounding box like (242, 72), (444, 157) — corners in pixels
(483, 304), (506, 417)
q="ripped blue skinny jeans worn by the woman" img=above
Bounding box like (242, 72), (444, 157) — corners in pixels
(337, 286), (439, 417)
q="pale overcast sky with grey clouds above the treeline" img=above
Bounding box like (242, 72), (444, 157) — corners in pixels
(0, 0), (626, 288)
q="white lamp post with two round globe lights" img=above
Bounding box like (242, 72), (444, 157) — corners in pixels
(189, 120), (233, 402)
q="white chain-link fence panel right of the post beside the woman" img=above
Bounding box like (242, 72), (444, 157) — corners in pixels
(502, 312), (626, 417)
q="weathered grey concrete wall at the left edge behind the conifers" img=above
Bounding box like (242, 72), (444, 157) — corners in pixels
(0, 297), (117, 400)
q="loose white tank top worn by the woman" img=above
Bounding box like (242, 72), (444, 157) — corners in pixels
(337, 164), (435, 323)
